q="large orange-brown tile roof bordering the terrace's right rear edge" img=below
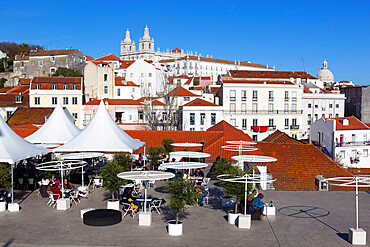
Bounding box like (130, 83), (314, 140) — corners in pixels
(257, 142), (352, 190)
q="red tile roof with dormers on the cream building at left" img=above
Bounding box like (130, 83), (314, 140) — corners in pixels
(31, 76), (82, 90)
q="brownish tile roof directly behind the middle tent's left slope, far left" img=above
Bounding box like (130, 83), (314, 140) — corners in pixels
(7, 107), (54, 125)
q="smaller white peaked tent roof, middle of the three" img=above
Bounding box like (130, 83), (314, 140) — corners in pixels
(25, 103), (81, 144)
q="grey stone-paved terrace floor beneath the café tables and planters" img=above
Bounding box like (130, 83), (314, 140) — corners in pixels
(0, 181), (370, 247)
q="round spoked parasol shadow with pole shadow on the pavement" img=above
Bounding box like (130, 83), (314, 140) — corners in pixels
(278, 206), (349, 242)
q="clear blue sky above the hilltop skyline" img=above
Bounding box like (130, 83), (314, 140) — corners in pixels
(0, 0), (370, 85)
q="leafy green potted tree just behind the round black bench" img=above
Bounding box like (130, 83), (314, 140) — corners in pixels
(100, 153), (133, 201)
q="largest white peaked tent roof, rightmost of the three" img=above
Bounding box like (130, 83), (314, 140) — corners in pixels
(54, 101), (145, 152)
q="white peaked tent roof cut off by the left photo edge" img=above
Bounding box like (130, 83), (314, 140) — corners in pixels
(0, 118), (50, 164)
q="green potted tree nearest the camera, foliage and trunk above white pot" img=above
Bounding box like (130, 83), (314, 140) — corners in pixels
(164, 178), (199, 224)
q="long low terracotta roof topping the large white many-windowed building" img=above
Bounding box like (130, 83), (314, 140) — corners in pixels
(230, 70), (317, 79)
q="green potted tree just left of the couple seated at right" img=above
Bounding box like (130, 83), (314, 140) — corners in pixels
(214, 158), (252, 213)
